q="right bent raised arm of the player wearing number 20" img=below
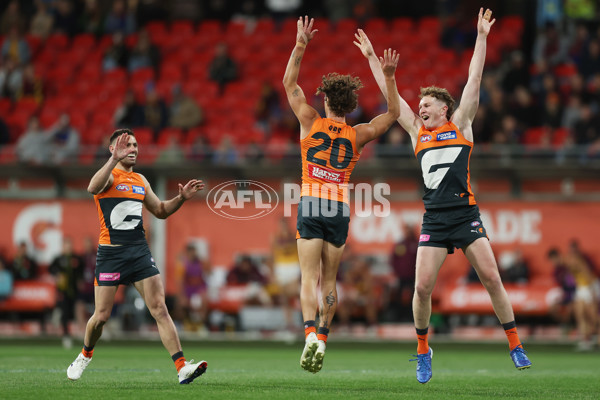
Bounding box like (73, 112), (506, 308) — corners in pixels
(355, 49), (400, 151)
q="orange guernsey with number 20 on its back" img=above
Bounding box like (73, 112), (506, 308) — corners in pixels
(300, 118), (360, 204)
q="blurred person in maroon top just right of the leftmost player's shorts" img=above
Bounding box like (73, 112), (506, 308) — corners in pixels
(181, 244), (210, 331)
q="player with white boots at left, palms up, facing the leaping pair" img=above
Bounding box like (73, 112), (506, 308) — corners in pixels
(67, 129), (207, 384)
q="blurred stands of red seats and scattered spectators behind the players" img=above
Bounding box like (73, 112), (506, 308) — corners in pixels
(0, 0), (600, 165)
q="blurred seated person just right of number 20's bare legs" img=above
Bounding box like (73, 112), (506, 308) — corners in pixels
(336, 257), (379, 328)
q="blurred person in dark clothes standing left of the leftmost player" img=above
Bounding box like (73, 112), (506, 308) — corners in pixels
(49, 237), (83, 348)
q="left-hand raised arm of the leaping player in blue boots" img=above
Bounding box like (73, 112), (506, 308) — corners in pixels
(354, 29), (423, 143)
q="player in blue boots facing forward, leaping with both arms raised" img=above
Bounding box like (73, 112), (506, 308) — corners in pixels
(354, 8), (531, 383)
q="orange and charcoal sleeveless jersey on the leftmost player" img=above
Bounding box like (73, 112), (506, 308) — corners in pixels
(94, 168), (146, 244)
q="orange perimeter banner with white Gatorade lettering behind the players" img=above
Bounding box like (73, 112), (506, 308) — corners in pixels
(0, 199), (600, 293)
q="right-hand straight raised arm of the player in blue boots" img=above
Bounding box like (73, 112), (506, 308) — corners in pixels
(451, 8), (496, 141)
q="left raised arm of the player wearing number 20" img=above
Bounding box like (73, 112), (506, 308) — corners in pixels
(283, 16), (319, 136)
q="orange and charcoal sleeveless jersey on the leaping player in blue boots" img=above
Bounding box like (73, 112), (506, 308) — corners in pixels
(415, 122), (476, 209)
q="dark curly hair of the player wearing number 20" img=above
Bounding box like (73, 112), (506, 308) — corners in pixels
(317, 72), (363, 117)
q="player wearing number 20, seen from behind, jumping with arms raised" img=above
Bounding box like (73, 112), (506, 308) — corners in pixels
(283, 16), (399, 373)
